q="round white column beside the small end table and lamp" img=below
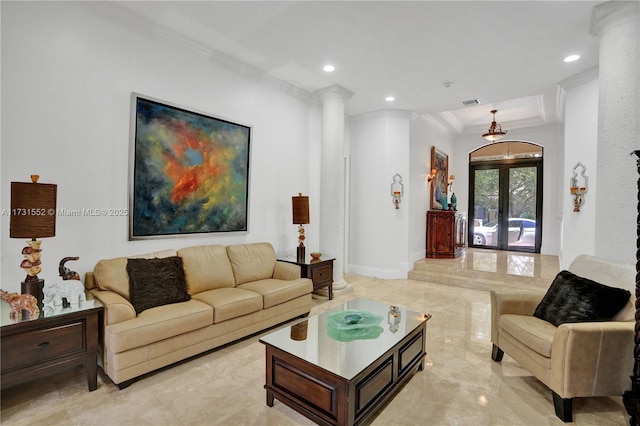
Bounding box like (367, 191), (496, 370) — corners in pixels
(316, 85), (353, 291)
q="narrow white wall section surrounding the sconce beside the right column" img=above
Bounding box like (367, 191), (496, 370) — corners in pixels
(560, 79), (598, 269)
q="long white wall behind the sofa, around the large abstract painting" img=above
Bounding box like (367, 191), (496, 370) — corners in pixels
(0, 2), (320, 291)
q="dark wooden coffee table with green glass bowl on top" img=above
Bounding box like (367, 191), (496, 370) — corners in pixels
(260, 299), (431, 425)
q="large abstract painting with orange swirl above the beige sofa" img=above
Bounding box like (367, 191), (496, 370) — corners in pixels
(129, 93), (251, 240)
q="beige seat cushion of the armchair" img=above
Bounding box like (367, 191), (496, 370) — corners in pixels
(498, 314), (556, 358)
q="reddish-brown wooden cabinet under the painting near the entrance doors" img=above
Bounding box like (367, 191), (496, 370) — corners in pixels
(426, 210), (467, 259)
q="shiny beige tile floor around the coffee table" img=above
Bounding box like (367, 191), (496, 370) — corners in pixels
(0, 253), (628, 426)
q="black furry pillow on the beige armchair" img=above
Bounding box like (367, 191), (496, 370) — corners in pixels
(533, 271), (631, 327)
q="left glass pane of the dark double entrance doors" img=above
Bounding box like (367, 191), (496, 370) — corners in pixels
(470, 168), (500, 247)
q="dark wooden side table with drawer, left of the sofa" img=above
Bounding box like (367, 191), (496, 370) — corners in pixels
(0, 294), (104, 391)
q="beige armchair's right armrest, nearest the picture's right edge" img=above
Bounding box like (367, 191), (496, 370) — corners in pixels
(549, 321), (635, 398)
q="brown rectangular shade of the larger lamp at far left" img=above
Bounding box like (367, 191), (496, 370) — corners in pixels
(9, 179), (58, 238)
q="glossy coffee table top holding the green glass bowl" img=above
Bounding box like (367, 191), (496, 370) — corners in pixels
(260, 299), (430, 380)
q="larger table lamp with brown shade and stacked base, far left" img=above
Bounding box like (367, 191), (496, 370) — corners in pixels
(9, 175), (58, 305)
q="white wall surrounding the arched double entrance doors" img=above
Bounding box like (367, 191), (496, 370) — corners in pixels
(449, 124), (563, 255)
